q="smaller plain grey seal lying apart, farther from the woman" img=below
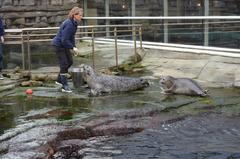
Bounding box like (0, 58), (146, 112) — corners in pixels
(159, 76), (207, 97)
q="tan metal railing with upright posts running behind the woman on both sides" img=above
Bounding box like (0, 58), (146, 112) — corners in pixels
(5, 24), (142, 72)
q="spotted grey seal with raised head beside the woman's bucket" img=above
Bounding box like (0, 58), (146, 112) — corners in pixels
(80, 64), (149, 95)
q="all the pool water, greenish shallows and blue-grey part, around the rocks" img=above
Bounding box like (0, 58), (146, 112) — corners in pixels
(0, 83), (240, 159)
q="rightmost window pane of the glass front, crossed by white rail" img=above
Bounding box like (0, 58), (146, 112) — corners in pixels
(209, 0), (240, 48)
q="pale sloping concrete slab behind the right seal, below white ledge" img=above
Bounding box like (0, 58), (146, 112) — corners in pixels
(142, 50), (240, 87)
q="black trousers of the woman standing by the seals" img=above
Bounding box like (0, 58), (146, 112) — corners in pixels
(54, 46), (73, 74)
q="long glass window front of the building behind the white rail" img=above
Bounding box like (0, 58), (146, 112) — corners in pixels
(83, 0), (240, 48)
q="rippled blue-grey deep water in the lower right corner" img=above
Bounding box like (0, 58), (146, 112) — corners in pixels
(108, 114), (240, 159)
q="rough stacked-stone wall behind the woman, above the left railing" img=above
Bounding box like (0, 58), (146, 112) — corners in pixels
(0, 0), (80, 29)
